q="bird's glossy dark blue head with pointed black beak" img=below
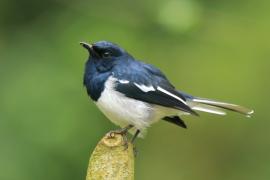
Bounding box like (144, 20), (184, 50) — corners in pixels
(80, 41), (130, 71)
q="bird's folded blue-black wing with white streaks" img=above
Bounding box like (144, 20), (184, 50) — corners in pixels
(115, 64), (198, 115)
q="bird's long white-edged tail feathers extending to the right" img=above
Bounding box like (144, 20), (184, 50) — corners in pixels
(188, 97), (254, 117)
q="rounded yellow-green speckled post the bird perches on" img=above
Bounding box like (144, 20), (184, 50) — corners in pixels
(86, 133), (134, 180)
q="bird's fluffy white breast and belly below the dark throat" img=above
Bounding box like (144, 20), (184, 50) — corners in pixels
(96, 77), (157, 130)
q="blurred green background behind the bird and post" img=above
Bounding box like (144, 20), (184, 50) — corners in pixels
(0, 0), (270, 180)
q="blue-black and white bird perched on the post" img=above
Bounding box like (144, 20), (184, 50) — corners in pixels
(80, 41), (254, 143)
